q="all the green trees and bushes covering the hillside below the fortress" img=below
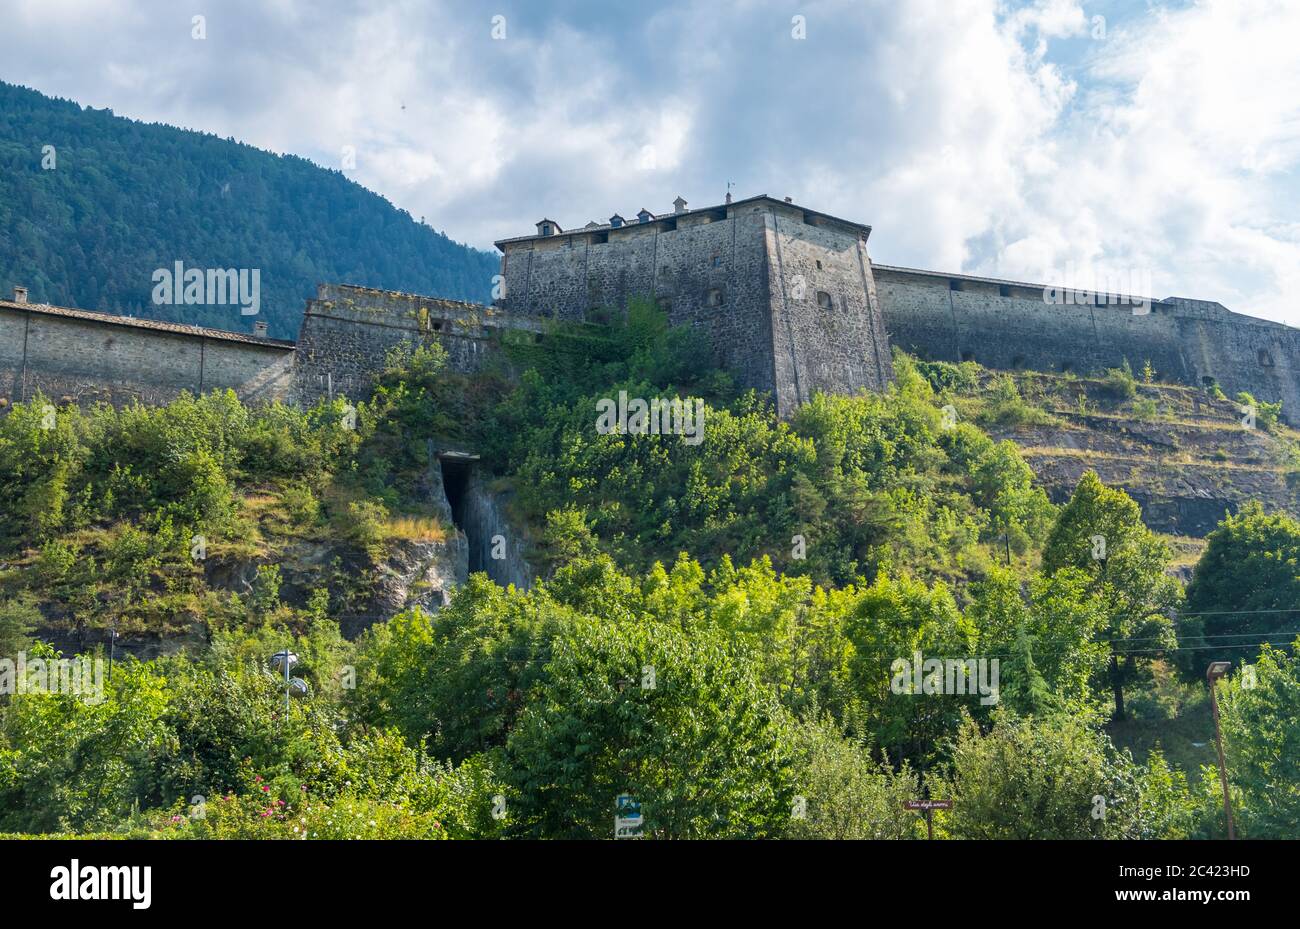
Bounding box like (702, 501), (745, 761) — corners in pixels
(0, 307), (1300, 838)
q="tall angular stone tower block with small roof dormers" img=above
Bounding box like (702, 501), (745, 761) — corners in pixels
(497, 196), (893, 416)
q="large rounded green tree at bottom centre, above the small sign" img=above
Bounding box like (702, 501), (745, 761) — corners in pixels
(504, 618), (794, 838)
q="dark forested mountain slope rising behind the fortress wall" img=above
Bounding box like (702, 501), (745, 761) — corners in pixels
(0, 82), (498, 339)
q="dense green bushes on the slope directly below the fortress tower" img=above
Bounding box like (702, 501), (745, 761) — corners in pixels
(481, 304), (1052, 583)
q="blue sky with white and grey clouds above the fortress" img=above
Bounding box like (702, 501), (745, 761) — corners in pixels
(0, 0), (1300, 325)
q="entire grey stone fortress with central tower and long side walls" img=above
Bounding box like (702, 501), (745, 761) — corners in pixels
(0, 195), (1300, 422)
